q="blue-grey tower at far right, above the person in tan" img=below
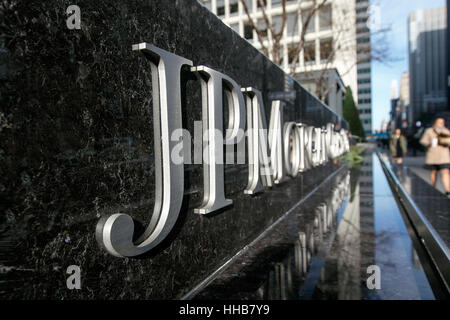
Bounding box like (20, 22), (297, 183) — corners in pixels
(408, 7), (447, 123)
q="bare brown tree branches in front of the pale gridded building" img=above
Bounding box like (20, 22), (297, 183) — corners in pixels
(240, 0), (390, 101)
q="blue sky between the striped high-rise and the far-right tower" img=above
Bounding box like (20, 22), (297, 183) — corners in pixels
(371, 0), (446, 130)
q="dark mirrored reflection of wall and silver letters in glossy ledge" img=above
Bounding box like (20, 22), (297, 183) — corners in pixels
(196, 170), (350, 299)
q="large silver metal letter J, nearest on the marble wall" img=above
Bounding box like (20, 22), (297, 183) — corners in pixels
(96, 43), (192, 257)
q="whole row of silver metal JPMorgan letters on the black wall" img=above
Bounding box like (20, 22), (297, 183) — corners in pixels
(96, 43), (349, 257)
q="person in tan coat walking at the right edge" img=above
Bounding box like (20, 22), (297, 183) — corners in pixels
(420, 117), (450, 196)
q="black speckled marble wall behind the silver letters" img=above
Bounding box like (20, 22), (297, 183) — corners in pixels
(0, 0), (346, 299)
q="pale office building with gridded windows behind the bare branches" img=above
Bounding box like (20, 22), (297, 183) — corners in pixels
(200, 0), (372, 124)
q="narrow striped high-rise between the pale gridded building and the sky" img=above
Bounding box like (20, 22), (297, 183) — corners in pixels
(355, 0), (372, 134)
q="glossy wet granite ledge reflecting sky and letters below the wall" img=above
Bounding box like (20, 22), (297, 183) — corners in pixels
(195, 153), (435, 300)
